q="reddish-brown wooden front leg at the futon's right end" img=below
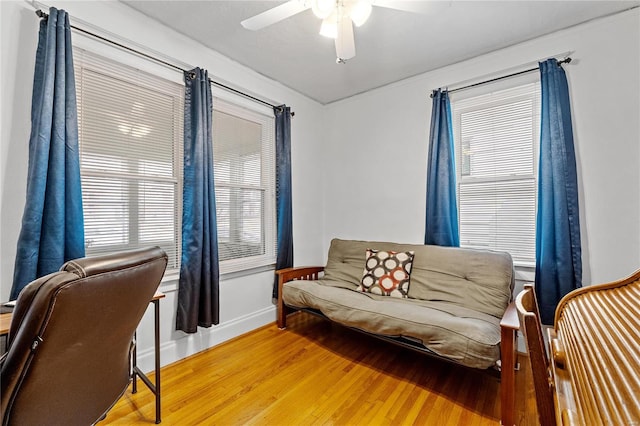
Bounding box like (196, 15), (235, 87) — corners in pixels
(500, 327), (517, 426)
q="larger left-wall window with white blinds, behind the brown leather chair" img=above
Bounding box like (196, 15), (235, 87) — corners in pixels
(74, 49), (184, 269)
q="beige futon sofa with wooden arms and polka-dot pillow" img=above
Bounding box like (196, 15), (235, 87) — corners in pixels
(276, 239), (518, 422)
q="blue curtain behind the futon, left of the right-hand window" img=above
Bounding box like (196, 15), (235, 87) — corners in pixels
(424, 89), (460, 247)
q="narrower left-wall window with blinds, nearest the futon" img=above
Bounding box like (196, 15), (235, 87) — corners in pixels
(213, 98), (276, 272)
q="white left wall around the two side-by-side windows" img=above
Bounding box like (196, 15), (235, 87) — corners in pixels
(0, 1), (324, 370)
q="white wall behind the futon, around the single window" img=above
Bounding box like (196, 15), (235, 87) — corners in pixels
(323, 9), (640, 284)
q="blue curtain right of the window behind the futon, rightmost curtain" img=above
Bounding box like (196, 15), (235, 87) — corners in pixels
(535, 59), (582, 324)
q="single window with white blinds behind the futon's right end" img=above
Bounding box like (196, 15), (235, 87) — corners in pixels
(451, 77), (540, 266)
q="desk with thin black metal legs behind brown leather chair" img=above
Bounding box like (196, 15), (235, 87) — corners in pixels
(0, 292), (165, 424)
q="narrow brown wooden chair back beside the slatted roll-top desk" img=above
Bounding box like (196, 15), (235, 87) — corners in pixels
(516, 284), (556, 426)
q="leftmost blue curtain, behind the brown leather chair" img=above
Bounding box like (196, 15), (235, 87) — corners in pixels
(11, 7), (85, 299)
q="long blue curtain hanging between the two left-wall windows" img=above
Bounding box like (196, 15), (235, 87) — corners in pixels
(176, 68), (220, 333)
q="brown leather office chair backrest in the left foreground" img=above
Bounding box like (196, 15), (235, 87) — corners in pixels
(0, 247), (167, 425)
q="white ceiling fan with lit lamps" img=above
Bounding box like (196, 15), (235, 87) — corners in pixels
(241, 0), (426, 64)
